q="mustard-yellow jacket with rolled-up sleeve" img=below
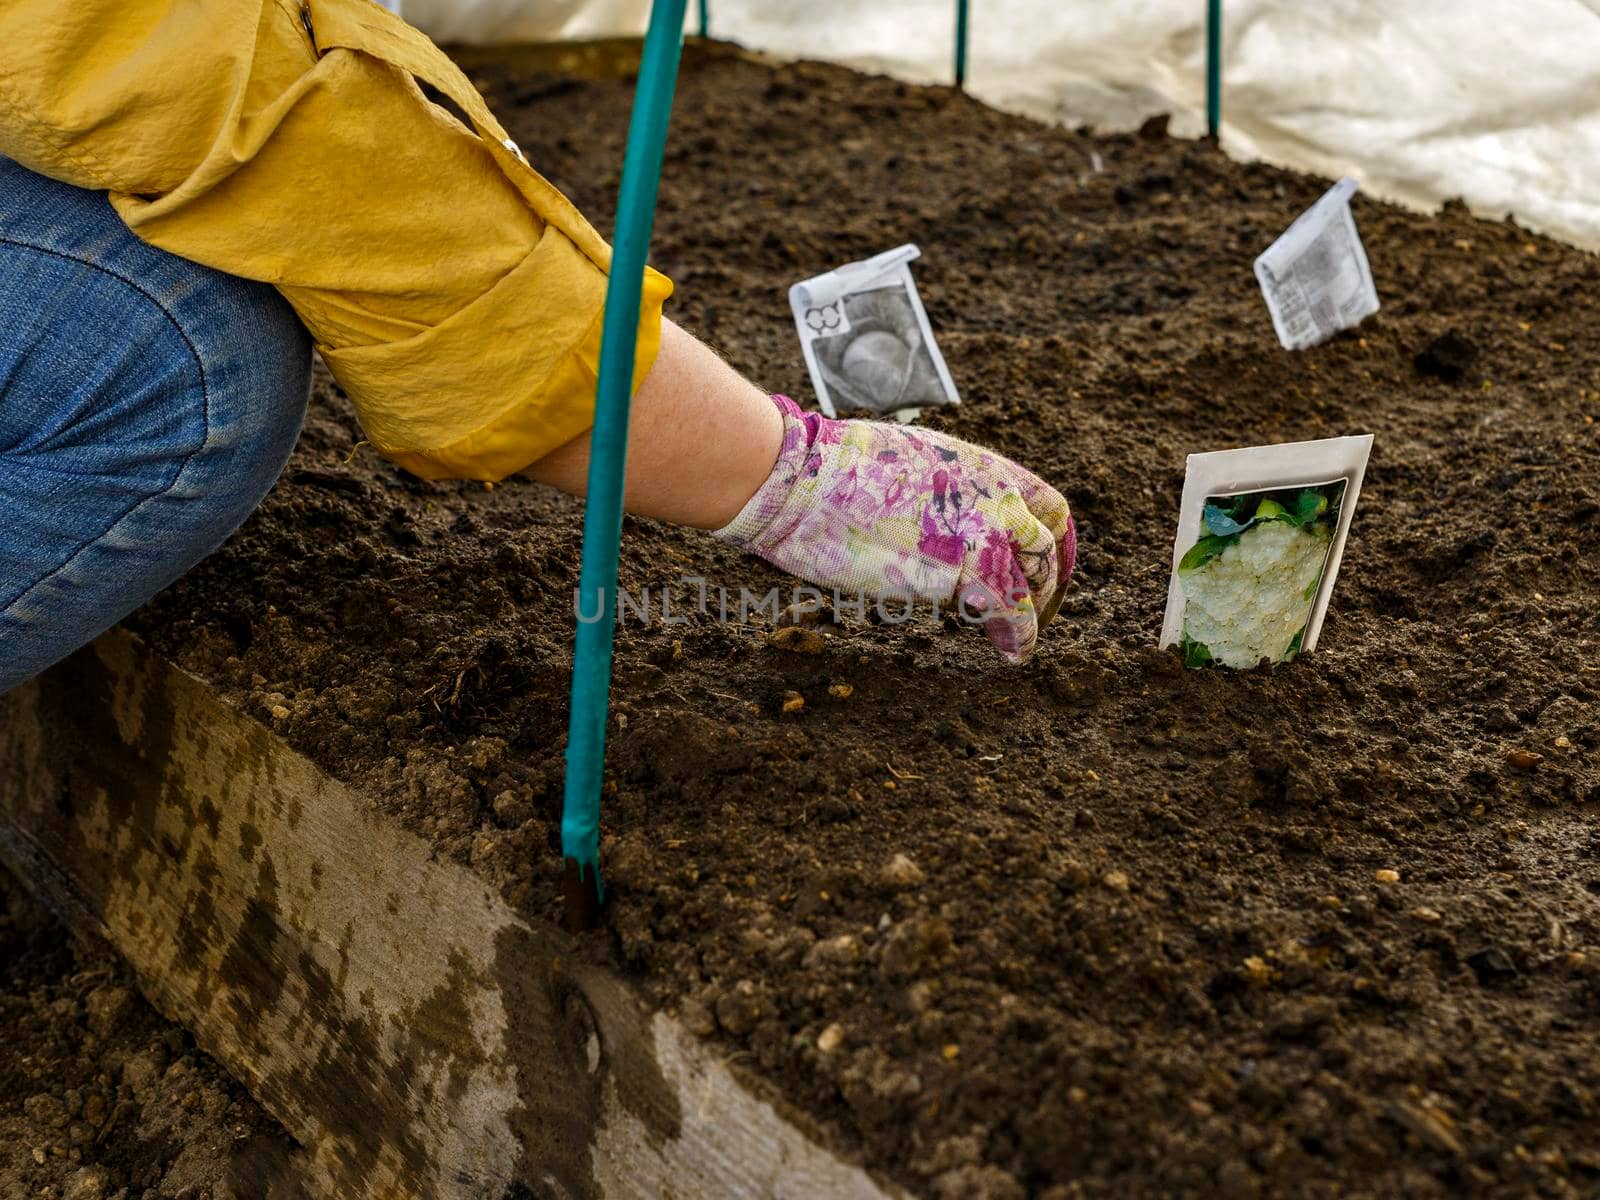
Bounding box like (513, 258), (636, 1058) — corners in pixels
(0, 0), (672, 480)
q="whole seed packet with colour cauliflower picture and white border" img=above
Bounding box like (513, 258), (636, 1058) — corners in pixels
(1162, 434), (1373, 667)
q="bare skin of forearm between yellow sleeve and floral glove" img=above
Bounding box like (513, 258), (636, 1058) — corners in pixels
(526, 322), (784, 530)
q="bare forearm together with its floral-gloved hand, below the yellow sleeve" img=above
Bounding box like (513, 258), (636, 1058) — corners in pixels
(528, 322), (1077, 662)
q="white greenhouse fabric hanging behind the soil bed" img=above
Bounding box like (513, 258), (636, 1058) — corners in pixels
(405, 0), (1600, 246)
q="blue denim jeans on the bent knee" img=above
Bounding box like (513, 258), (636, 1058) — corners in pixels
(0, 158), (310, 691)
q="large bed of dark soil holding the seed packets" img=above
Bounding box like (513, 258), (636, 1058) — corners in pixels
(121, 42), (1600, 1200)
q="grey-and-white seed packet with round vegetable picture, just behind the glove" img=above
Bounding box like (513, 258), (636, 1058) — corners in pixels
(789, 245), (960, 419)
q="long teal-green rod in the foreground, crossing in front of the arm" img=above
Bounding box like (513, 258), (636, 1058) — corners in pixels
(562, 0), (688, 925)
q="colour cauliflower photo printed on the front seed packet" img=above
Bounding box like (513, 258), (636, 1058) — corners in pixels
(1178, 480), (1344, 667)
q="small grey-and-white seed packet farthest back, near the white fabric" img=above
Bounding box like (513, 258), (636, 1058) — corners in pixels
(1256, 179), (1378, 350)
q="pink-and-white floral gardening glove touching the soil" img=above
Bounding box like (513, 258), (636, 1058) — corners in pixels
(715, 395), (1077, 662)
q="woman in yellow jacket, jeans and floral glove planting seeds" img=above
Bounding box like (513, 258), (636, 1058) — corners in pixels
(0, 0), (1074, 690)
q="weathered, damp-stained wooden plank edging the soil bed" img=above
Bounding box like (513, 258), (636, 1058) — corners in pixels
(0, 634), (894, 1200)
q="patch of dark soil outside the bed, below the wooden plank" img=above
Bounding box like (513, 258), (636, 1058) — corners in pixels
(0, 870), (293, 1200)
